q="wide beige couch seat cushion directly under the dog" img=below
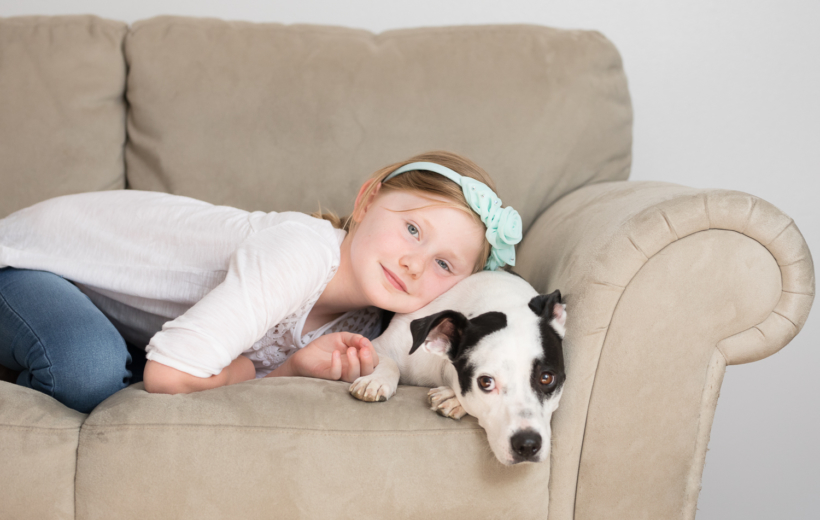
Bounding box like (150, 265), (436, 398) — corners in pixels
(77, 378), (549, 520)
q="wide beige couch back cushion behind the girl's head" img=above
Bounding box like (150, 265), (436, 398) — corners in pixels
(125, 17), (632, 231)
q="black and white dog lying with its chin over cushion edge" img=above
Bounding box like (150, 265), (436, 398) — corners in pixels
(350, 271), (567, 465)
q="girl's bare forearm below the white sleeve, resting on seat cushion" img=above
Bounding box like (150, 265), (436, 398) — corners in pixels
(143, 356), (256, 394)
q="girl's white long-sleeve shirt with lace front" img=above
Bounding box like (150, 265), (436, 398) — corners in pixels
(0, 190), (379, 377)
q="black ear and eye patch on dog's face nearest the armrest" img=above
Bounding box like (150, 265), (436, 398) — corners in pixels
(529, 291), (567, 403)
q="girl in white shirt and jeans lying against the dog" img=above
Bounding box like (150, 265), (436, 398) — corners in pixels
(0, 152), (521, 413)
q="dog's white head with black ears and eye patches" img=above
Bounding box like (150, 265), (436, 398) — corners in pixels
(410, 291), (567, 465)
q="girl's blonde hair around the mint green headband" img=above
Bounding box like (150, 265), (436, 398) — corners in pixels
(313, 151), (498, 273)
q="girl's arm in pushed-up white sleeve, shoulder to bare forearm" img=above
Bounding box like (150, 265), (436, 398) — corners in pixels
(146, 222), (338, 386)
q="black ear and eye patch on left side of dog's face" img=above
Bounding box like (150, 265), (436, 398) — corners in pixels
(410, 310), (507, 395)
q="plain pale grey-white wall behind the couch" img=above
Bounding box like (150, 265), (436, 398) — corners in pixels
(0, 0), (820, 520)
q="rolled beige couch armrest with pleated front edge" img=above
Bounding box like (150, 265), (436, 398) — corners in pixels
(516, 182), (814, 520)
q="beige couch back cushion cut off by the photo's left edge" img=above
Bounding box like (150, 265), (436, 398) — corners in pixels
(0, 16), (128, 218)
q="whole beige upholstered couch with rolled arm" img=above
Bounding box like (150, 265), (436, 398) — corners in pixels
(0, 17), (814, 520)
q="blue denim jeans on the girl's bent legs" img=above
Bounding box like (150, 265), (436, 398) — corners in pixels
(0, 267), (144, 413)
